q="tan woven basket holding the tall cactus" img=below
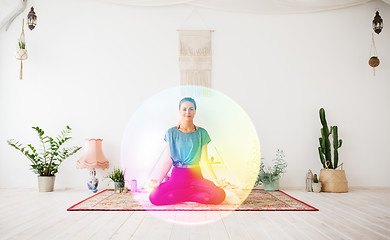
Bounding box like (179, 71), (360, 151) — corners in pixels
(319, 168), (348, 193)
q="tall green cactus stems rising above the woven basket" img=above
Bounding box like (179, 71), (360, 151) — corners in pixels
(318, 108), (343, 169)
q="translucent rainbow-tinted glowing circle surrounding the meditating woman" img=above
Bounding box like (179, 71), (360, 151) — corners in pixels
(121, 86), (260, 224)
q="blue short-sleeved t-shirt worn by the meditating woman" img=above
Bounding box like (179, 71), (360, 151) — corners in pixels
(164, 127), (211, 167)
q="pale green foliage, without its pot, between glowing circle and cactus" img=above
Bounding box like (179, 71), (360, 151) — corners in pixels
(255, 149), (288, 185)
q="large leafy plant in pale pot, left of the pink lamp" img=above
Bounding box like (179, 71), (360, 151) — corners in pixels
(7, 126), (81, 192)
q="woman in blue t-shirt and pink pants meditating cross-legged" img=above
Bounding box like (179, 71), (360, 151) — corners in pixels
(149, 98), (226, 205)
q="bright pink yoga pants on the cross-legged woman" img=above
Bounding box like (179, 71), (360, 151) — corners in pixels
(149, 167), (226, 205)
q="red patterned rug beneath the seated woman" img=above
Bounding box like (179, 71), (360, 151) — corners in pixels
(67, 189), (318, 211)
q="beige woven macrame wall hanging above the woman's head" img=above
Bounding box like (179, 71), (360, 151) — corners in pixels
(178, 30), (212, 94)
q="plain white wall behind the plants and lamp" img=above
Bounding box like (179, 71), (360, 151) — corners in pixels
(0, 0), (390, 188)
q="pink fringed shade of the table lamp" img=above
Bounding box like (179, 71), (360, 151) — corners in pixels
(77, 139), (109, 170)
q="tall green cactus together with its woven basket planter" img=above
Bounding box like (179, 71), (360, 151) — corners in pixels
(318, 108), (348, 193)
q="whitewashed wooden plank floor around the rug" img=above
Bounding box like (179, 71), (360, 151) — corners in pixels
(0, 188), (390, 240)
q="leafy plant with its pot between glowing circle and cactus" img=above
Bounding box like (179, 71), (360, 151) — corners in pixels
(255, 149), (287, 191)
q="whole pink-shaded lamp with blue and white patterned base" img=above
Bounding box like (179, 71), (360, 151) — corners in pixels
(77, 139), (109, 193)
